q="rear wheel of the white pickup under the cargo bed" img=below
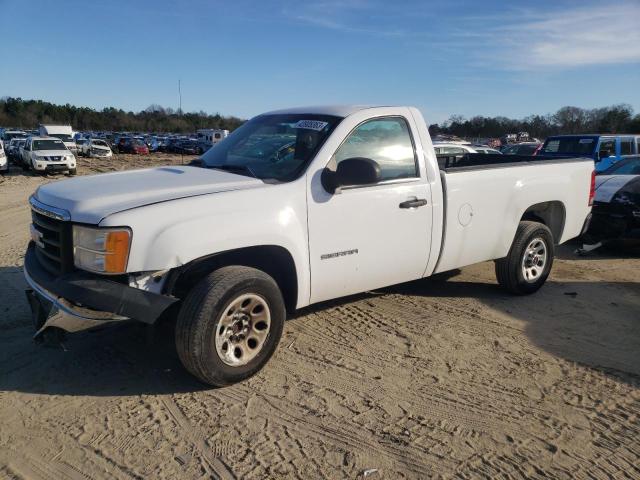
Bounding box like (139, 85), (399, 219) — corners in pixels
(495, 221), (554, 295)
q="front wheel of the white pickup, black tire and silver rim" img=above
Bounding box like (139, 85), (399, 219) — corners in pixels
(176, 266), (286, 387)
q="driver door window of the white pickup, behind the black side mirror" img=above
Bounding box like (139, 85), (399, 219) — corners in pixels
(334, 117), (418, 182)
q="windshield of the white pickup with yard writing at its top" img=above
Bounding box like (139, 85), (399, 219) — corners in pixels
(201, 114), (342, 182)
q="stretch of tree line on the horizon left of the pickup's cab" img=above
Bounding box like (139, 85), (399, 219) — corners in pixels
(0, 97), (244, 133)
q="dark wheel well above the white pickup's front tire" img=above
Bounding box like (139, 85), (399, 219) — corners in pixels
(165, 245), (298, 312)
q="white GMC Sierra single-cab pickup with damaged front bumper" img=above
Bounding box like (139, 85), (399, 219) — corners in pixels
(24, 107), (594, 385)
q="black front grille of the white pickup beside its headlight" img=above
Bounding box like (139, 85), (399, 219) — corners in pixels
(31, 210), (74, 275)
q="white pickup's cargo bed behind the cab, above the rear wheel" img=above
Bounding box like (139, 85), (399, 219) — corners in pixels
(435, 154), (594, 272)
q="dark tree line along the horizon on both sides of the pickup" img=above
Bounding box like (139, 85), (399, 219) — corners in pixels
(0, 97), (640, 138)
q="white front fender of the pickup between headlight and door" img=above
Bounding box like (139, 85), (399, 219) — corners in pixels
(100, 181), (309, 306)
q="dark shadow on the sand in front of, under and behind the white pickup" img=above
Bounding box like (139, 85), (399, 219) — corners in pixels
(0, 267), (640, 396)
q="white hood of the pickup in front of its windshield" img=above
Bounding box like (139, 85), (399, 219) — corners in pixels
(35, 166), (266, 225)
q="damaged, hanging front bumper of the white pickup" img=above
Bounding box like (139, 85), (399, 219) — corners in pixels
(24, 244), (178, 337)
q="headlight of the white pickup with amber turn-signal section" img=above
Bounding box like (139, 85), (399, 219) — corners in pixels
(73, 225), (131, 274)
